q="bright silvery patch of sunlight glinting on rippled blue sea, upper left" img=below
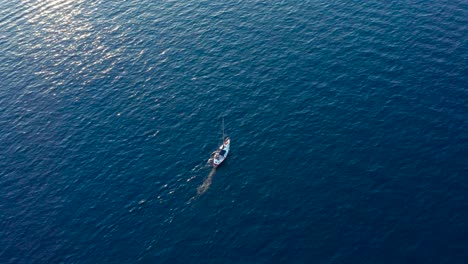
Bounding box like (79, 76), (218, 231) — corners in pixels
(18, 0), (119, 93)
